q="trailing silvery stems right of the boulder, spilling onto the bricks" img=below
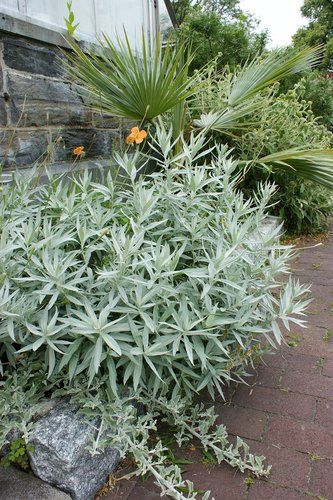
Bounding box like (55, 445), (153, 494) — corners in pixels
(50, 379), (270, 500)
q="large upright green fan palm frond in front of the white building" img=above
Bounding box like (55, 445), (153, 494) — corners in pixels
(67, 33), (198, 120)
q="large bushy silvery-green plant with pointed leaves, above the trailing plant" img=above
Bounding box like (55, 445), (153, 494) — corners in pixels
(0, 134), (307, 397)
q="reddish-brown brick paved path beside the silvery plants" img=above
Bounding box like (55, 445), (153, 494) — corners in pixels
(105, 226), (333, 500)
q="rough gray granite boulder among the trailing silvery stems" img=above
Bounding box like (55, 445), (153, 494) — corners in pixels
(29, 402), (120, 500)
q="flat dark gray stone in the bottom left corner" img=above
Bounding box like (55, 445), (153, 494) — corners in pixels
(0, 467), (70, 500)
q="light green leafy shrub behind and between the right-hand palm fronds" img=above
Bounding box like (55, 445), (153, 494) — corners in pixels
(192, 68), (333, 234)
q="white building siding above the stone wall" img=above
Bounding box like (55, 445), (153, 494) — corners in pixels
(0, 0), (175, 47)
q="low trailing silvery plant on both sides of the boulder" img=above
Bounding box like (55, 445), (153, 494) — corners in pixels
(0, 370), (270, 500)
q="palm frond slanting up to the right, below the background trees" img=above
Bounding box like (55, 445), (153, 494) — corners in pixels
(228, 46), (323, 107)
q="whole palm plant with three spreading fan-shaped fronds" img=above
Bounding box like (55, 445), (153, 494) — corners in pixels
(63, 5), (333, 188)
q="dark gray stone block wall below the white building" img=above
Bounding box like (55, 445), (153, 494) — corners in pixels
(0, 31), (122, 169)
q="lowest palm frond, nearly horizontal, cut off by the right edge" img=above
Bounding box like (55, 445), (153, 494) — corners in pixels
(256, 149), (333, 189)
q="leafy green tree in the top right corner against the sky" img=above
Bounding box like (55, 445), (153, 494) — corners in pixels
(293, 0), (333, 69)
